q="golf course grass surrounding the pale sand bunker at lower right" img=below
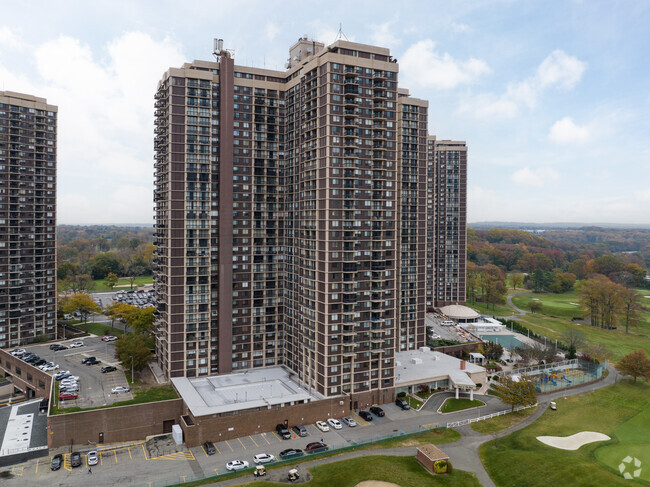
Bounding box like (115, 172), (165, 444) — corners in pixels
(479, 380), (650, 487)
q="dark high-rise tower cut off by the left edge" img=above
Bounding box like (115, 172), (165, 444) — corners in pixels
(0, 91), (57, 347)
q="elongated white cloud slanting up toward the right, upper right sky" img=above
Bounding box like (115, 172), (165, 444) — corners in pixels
(458, 50), (587, 119)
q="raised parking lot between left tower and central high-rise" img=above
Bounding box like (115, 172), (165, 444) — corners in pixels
(13, 336), (132, 408)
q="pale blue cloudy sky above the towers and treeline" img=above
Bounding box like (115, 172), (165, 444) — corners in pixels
(0, 0), (650, 224)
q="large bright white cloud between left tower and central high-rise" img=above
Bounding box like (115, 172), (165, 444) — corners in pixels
(0, 32), (185, 223)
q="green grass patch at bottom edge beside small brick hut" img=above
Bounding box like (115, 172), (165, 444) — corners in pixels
(230, 456), (481, 487)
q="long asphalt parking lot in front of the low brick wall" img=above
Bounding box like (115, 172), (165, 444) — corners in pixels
(8, 404), (432, 485)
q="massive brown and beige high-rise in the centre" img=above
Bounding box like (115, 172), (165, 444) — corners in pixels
(154, 39), (460, 402)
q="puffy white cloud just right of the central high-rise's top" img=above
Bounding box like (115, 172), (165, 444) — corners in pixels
(399, 39), (490, 90)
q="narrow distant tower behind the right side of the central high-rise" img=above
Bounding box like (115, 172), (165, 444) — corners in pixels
(427, 136), (467, 308)
